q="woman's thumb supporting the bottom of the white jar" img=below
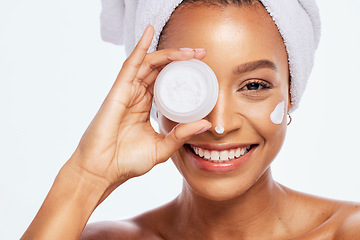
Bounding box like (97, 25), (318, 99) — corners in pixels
(157, 119), (211, 163)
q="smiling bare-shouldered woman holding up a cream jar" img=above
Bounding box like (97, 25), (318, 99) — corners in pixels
(22, 1), (360, 239)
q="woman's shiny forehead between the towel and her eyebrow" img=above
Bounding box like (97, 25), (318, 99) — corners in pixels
(159, 3), (287, 74)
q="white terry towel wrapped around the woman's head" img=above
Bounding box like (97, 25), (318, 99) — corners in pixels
(101, 0), (321, 111)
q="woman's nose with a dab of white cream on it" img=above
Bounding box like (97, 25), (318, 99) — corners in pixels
(206, 88), (242, 136)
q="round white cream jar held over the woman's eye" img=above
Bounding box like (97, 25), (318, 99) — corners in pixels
(154, 59), (219, 123)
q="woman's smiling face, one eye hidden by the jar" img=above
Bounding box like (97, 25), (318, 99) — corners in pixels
(159, 4), (289, 200)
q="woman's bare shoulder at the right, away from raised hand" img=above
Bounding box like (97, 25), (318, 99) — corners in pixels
(283, 187), (360, 240)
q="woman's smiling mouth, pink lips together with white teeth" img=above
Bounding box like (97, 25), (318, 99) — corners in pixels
(185, 144), (258, 174)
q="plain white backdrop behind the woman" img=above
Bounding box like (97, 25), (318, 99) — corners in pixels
(0, 0), (360, 239)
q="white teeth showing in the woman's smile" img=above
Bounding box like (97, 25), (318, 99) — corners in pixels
(191, 145), (251, 163)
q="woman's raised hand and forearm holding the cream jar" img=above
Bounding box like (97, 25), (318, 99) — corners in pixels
(21, 26), (211, 240)
